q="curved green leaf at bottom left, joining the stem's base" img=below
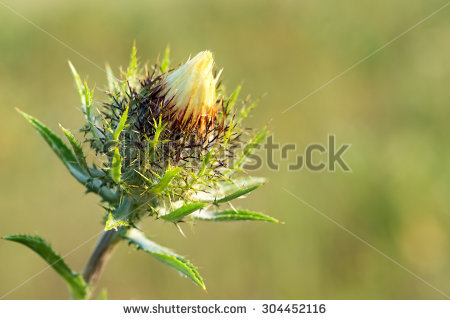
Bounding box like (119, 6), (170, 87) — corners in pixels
(3, 235), (89, 299)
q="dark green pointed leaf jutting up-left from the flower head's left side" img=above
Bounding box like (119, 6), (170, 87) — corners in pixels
(17, 109), (89, 185)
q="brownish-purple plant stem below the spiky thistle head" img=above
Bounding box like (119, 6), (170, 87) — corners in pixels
(83, 230), (120, 291)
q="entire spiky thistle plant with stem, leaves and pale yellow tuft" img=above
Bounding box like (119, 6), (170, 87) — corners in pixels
(7, 47), (278, 299)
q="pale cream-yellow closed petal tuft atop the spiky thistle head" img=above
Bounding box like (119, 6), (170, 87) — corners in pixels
(159, 51), (220, 135)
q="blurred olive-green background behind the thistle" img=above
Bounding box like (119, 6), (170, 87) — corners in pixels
(0, 0), (450, 299)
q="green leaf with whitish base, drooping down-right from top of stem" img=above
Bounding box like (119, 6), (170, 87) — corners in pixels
(124, 228), (206, 291)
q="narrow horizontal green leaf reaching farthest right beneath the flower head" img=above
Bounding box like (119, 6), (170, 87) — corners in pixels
(190, 210), (280, 223)
